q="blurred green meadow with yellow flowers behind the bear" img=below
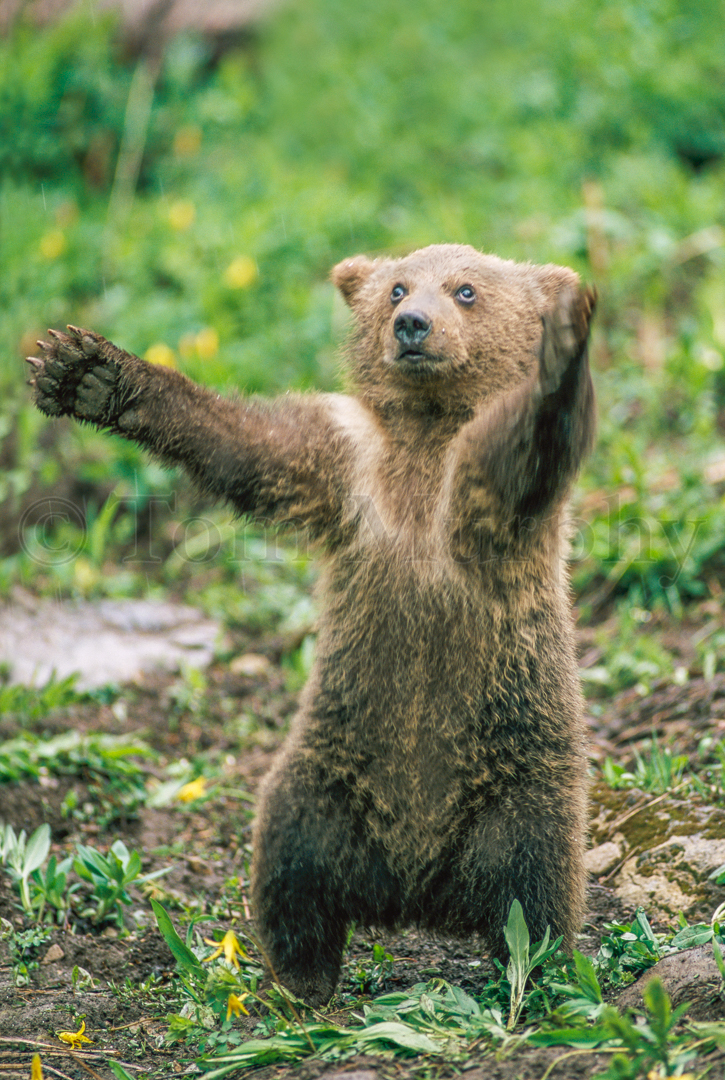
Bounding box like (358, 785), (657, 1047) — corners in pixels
(0, 0), (725, 611)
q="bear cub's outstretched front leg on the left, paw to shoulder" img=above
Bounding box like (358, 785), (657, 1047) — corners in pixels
(27, 326), (349, 537)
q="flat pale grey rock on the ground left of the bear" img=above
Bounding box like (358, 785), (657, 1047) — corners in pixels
(0, 599), (219, 690)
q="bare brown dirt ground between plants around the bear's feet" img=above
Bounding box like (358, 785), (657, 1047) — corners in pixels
(0, 613), (725, 1080)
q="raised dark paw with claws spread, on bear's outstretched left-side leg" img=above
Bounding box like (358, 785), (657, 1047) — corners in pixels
(27, 326), (144, 428)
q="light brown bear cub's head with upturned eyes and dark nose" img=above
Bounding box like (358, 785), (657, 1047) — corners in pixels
(332, 244), (579, 411)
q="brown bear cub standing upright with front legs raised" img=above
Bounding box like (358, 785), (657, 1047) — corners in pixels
(29, 244), (594, 1003)
